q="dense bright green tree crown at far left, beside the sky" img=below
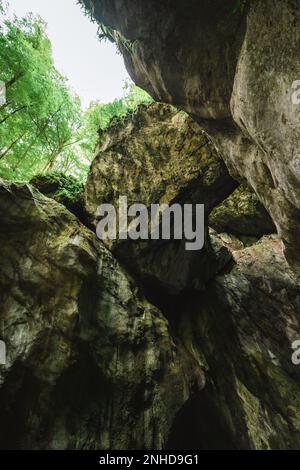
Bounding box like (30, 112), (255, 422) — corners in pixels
(0, 11), (81, 179)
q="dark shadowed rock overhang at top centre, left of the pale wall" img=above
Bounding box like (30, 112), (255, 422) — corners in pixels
(81, 0), (244, 119)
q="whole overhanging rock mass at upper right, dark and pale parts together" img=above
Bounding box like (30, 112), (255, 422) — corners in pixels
(82, 0), (300, 273)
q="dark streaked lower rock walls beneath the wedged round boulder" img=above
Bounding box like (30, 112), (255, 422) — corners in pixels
(0, 178), (300, 449)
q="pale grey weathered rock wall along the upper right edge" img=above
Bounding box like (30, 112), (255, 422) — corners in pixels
(231, 0), (300, 273)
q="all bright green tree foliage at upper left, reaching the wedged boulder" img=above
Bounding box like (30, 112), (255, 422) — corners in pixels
(0, 7), (151, 181)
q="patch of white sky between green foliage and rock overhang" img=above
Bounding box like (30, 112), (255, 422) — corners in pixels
(9, 0), (129, 107)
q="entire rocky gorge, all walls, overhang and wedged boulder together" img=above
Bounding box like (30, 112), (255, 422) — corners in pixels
(0, 0), (300, 451)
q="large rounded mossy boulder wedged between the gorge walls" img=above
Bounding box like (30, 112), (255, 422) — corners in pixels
(86, 103), (237, 293)
